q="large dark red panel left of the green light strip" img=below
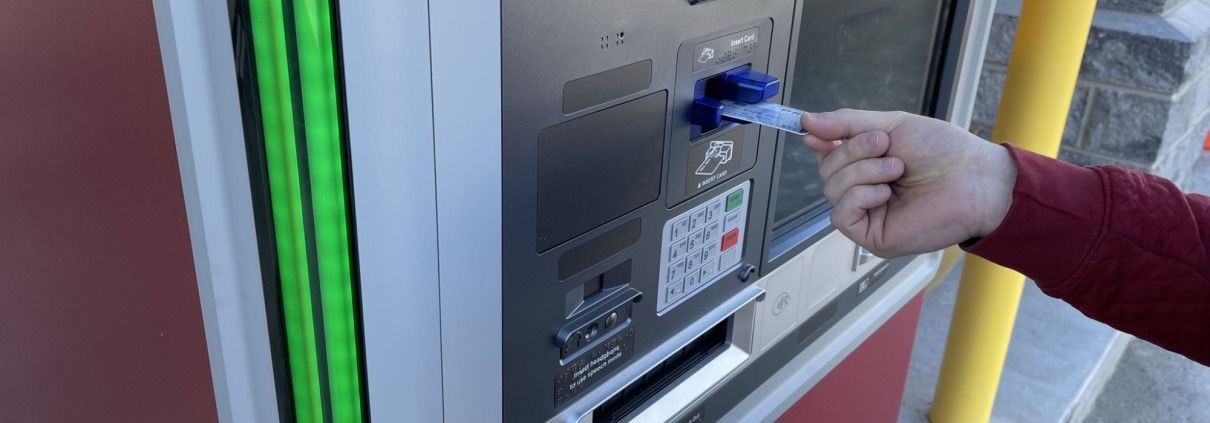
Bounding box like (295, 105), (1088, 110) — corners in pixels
(0, 0), (217, 422)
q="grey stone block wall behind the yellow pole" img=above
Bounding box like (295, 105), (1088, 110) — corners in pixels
(970, 0), (1210, 189)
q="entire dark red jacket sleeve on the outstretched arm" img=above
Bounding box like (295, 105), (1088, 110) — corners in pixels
(968, 145), (1210, 365)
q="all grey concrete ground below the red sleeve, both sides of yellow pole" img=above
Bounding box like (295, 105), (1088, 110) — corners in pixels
(899, 152), (1210, 423)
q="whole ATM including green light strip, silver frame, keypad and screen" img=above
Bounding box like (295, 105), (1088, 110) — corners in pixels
(148, 0), (993, 423)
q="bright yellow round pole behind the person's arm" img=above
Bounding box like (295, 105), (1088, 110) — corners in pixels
(929, 0), (1096, 423)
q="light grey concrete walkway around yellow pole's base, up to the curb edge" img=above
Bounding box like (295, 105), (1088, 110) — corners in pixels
(899, 257), (1120, 423)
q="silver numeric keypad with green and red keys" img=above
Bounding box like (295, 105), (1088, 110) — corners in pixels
(656, 181), (751, 314)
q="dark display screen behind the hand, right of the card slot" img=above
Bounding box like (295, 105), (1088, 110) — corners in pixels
(773, 0), (947, 231)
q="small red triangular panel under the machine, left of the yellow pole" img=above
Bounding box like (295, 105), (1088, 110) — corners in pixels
(778, 292), (924, 423)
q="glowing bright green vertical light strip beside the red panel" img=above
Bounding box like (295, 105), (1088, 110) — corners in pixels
(248, 0), (363, 422)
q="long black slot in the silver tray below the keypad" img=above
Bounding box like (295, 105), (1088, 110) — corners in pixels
(593, 320), (727, 422)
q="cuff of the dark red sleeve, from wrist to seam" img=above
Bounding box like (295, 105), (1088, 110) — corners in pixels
(963, 144), (1106, 289)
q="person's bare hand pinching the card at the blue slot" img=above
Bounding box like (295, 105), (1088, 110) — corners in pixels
(802, 109), (1016, 257)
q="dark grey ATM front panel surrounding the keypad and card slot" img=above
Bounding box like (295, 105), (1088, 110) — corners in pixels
(498, 0), (963, 422)
